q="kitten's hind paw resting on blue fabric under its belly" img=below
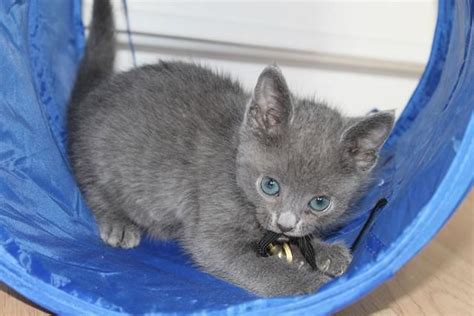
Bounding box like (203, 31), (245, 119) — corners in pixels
(99, 221), (141, 249)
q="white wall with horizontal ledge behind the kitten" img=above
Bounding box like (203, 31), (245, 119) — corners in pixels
(84, 0), (437, 115)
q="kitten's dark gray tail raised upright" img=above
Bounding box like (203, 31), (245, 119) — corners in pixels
(71, 0), (115, 104)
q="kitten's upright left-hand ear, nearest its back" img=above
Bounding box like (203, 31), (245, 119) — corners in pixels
(246, 65), (292, 136)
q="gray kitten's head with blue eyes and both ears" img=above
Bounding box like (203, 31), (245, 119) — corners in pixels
(237, 66), (394, 236)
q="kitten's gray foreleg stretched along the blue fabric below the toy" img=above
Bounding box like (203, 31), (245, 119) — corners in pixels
(188, 240), (331, 296)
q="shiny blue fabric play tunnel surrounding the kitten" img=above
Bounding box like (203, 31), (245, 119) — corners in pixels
(0, 0), (474, 315)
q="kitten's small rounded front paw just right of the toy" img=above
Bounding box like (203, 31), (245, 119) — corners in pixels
(316, 244), (352, 277)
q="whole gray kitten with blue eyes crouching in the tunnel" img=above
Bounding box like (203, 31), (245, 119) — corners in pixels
(69, 0), (394, 296)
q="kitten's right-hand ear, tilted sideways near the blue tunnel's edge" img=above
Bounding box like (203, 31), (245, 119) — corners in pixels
(341, 111), (395, 172)
